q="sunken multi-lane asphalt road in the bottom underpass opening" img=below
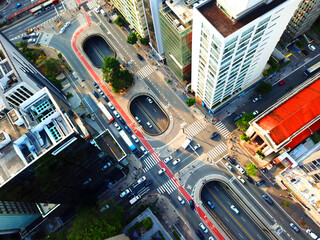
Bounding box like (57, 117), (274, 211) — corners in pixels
(201, 182), (269, 240)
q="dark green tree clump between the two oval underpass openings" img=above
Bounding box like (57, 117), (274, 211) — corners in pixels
(102, 57), (133, 92)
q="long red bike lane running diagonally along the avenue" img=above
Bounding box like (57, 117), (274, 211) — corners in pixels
(72, 0), (225, 240)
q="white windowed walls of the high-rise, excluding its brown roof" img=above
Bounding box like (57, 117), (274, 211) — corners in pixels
(191, 0), (299, 108)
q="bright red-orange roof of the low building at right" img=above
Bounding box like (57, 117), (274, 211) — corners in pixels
(257, 79), (320, 145)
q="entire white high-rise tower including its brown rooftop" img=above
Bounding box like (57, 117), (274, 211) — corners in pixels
(191, 0), (300, 109)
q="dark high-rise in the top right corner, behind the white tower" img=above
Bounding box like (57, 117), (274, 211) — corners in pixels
(280, 0), (320, 46)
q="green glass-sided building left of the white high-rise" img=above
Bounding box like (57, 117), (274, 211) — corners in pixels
(160, 0), (193, 81)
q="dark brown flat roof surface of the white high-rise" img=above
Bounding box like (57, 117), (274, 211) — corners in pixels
(198, 0), (286, 37)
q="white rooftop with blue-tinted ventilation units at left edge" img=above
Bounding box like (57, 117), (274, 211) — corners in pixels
(0, 88), (74, 186)
